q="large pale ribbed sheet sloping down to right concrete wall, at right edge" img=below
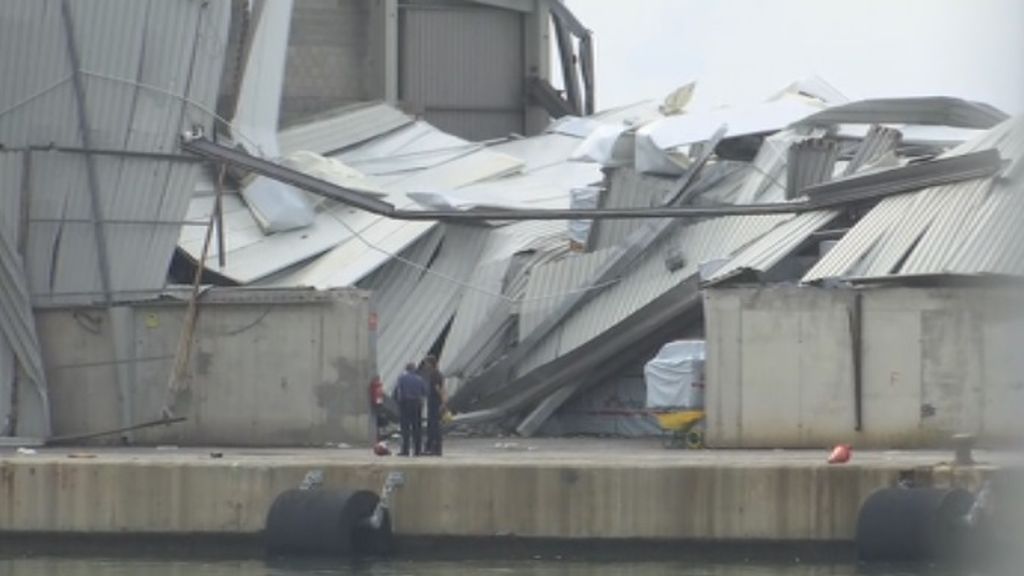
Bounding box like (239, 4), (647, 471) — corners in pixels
(803, 120), (1024, 283)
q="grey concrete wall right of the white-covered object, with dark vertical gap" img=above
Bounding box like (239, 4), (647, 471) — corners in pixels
(705, 286), (1024, 448)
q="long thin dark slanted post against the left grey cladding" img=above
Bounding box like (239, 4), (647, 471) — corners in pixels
(60, 0), (112, 304)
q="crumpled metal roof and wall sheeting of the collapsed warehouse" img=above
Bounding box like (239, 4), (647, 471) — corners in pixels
(0, 0), (1024, 435)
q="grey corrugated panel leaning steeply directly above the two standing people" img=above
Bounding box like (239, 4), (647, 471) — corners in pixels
(377, 225), (487, 386)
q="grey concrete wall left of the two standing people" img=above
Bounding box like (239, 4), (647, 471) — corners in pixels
(37, 290), (376, 446)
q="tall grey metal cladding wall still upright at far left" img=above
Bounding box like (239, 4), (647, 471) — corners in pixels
(0, 0), (229, 303)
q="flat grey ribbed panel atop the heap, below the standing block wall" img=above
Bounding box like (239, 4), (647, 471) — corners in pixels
(278, 102), (413, 155)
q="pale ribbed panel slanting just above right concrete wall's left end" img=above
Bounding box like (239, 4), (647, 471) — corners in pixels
(708, 210), (839, 284)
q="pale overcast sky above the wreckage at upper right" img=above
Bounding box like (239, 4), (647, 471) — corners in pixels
(554, 0), (1024, 113)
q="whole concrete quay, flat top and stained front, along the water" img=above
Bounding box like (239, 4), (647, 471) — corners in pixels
(0, 439), (1013, 542)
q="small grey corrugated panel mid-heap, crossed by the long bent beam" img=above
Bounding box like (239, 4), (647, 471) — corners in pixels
(590, 168), (675, 250)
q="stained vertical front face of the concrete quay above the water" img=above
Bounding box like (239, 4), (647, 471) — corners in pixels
(0, 458), (899, 541)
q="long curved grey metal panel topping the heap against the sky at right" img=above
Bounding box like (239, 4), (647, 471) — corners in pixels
(798, 96), (1009, 129)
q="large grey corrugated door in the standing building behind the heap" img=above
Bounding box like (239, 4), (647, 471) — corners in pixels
(399, 5), (525, 140)
